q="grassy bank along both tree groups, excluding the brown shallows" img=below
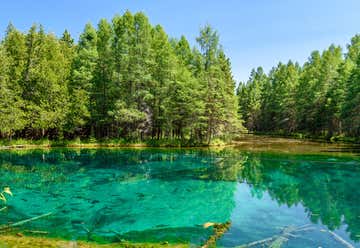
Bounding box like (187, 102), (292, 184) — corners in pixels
(0, 132), (360, 149)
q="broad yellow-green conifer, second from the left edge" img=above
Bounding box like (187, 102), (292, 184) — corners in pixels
(17, 25), (68, 137)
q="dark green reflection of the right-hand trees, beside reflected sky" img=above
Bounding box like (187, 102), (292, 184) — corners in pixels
(238, 155), (360, 240)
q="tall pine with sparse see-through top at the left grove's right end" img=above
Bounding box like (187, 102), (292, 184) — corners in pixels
(197, 25), (240, 143)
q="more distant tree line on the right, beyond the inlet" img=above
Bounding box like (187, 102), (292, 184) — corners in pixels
(237, 35), (360, 138)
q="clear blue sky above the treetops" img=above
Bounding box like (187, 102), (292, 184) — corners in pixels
(0, 0), (360, 81)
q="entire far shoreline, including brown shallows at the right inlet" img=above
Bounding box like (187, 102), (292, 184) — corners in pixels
(0, 133), (360, 150)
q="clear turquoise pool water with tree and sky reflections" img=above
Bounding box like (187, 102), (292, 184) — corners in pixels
(0, 149), (360, 247)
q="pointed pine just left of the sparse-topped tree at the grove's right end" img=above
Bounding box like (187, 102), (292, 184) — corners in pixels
(172, 36), (206, 141)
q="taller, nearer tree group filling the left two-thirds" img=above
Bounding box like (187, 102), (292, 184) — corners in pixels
(0, 12), (242, 142)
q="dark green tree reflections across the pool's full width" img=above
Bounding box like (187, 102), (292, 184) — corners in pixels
(0, 149), (360, 240)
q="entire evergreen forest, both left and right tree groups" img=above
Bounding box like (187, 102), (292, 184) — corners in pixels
(0, 11), (360, 144)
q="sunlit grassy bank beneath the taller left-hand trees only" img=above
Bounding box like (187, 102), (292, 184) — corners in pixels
(0, 138), (229, 149)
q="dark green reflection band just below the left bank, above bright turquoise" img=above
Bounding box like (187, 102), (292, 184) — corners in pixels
(0, 149), (246, 183)
